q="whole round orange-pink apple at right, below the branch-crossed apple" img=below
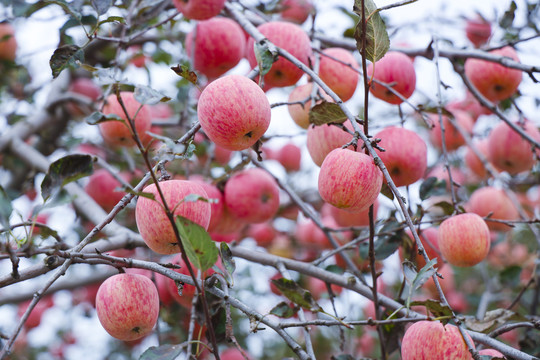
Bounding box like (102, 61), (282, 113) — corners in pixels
(438, 213), (491, 267)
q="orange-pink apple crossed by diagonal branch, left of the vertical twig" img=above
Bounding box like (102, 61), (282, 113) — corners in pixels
(319, 48), (359, 101)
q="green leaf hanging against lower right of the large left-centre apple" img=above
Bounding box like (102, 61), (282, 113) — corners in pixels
(175, 216), (218, 271)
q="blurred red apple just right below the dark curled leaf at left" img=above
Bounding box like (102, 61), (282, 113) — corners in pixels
(84, 169), (126, 212)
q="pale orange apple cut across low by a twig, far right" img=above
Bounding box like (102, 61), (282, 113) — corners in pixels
(465, 186), (519, 231)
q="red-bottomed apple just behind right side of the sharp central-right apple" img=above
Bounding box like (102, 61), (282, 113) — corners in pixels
(375, 126), (427, 186)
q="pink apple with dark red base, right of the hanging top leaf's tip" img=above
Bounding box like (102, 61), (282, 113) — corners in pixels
(367, 51), (416, 105)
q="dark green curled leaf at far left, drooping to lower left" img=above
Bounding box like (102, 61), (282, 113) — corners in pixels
(41, 154), (94, 200)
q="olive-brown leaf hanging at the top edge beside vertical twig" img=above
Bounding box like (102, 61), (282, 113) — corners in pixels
(353, 0), (390, 63)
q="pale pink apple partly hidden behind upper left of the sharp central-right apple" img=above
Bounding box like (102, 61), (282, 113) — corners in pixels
(306, 120), (354, 167)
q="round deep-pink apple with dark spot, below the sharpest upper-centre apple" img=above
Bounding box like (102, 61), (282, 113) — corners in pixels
(223, 168), (279, 223)
